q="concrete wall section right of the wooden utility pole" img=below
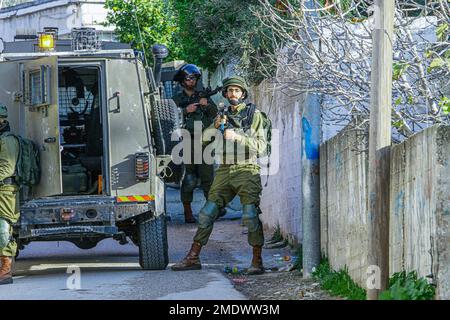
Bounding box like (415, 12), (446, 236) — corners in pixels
(389, 126), (450, 299)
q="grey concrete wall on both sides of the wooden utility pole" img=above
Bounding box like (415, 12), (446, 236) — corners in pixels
(320, 126), (450, 299)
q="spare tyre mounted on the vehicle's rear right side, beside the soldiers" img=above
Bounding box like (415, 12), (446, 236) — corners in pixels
(152, 99), (183, 183)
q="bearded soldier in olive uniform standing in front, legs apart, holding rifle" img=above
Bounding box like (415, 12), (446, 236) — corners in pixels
(172, 76), (267, 274)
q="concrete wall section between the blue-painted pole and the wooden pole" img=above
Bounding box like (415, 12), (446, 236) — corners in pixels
(320, 132), (368, 285)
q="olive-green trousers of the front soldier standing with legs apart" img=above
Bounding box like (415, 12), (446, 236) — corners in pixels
(194, 164), (264, 246)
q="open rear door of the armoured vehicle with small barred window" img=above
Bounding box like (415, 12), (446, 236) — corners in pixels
(19, 57), (62, 198)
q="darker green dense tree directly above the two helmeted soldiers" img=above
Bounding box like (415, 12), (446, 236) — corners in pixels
(170, 0), (275, 83)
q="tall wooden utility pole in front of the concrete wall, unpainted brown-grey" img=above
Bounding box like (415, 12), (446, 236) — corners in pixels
(367, 0), (395, 300)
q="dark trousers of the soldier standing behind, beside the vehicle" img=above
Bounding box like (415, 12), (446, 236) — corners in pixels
(180, 144), (214, 202)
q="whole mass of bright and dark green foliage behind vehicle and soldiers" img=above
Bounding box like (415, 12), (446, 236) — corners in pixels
(105, 0), (277, 83)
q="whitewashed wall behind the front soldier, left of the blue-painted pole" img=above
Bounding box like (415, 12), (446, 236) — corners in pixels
(250, 82), (304, 243)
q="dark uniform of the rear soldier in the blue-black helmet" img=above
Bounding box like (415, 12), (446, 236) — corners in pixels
(172, 90), (217, 203)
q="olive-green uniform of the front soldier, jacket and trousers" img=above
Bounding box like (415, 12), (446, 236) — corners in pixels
(194, 103), (267, 246)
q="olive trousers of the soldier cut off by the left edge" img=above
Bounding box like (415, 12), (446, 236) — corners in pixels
(0, 185), (20, 257)
